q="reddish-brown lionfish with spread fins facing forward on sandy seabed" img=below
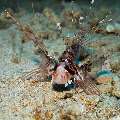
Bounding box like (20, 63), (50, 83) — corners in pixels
(5, 10), (100, 95)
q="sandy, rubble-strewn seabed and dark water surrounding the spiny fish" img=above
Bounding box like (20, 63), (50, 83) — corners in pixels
(0, 0), (120, 120)
